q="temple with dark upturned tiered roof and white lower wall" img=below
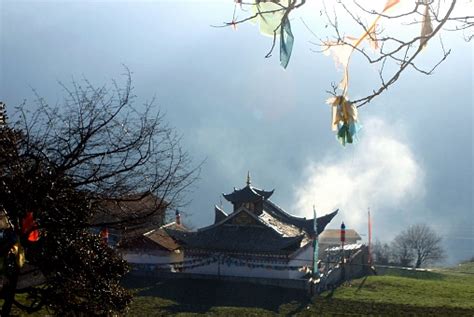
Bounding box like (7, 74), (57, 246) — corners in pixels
(164, 176), (337, 279)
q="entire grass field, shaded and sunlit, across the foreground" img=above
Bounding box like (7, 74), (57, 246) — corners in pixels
(3, 262), (474, 317)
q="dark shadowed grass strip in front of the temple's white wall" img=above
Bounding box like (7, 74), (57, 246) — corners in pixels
(126, 278), (306, 316)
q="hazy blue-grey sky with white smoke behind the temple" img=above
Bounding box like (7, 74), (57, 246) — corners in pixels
(0, 0), (474, 264)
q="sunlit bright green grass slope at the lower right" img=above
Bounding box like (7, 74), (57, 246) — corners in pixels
(301, 263), (474, 316)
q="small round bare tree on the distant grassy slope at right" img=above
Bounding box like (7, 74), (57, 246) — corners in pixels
(392, 224), (444, 268)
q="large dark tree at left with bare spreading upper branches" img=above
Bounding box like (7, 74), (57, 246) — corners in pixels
(0, 72), (199, 316)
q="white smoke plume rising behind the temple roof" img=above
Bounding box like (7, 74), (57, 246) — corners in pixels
(295, 118), (425, 232)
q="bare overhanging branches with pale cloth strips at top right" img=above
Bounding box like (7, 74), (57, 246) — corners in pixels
(218, 0), (474, 107)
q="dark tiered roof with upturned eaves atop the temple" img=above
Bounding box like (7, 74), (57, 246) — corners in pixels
(165, 178), (338, 254)
